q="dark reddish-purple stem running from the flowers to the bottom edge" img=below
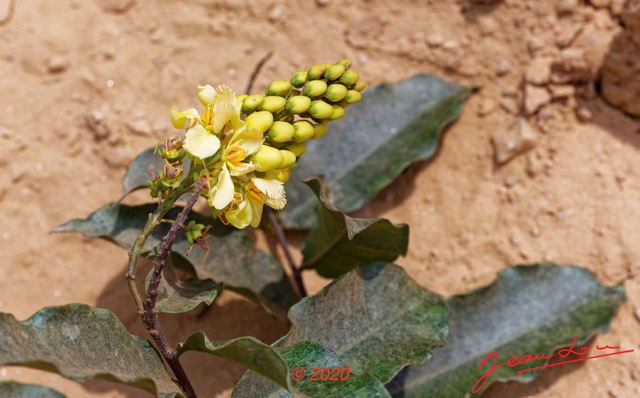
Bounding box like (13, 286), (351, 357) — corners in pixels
(142, 180), (202, 398)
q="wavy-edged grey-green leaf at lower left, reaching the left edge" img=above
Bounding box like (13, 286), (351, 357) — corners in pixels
(0, 304), (182, 397)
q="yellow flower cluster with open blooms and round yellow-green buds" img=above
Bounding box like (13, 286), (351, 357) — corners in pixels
(171, 60), (365, 228)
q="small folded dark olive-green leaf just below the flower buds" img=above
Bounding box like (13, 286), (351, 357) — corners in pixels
(303, 179), (409, 278)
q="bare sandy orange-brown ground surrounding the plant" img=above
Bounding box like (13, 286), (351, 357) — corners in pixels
(0, 0), (640, 398)
